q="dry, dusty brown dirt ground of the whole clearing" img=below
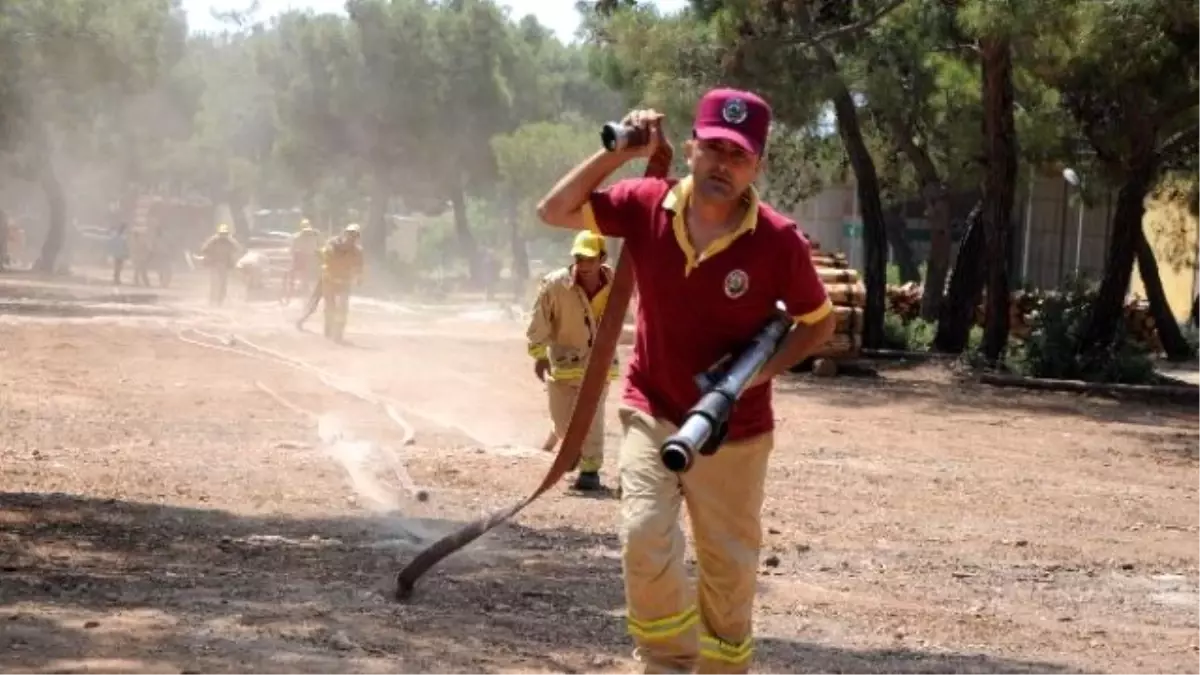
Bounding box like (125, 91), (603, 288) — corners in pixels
(0, 265), (1200, 674)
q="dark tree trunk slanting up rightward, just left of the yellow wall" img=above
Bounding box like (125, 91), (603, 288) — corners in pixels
(1079, 161), (1158, 352)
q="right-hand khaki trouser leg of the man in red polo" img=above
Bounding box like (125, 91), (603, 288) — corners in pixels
(682, 432), (774, 675)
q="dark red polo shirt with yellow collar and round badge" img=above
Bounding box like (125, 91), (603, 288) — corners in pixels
(583, 172), (833, 441)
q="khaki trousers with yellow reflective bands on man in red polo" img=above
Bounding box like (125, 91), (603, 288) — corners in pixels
(619, 408), (774, 675)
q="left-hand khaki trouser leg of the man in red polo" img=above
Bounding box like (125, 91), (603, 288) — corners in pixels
(619, 410), (700, 673)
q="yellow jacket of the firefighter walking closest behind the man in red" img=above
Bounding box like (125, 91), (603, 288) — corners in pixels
(526, 265), (620, 382)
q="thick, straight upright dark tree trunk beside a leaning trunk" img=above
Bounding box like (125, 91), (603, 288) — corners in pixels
(979, 38), (1016, 364)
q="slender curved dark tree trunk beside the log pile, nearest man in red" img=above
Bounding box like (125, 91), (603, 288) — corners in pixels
(827, 82), (888, 350)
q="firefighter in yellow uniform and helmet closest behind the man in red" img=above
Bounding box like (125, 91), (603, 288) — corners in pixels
(526, 231), (618, 491)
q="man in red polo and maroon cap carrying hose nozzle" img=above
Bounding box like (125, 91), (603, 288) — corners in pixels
(538, 89), (834, 674)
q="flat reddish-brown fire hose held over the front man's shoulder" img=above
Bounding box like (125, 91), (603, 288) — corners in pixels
(396, 124), (673, 601)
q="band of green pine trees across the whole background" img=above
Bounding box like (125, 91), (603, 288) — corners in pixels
(0, 0), (1200, 367)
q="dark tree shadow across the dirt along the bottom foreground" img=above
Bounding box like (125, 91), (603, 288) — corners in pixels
(0, 492), (1099, 675)
